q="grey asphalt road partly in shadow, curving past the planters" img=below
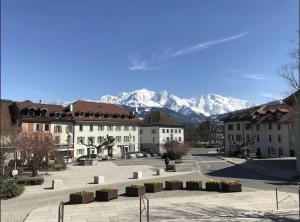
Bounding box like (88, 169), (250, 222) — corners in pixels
(190, 148), (298, 193)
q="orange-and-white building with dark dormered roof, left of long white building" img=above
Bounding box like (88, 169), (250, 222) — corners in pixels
(11, 101), (74, 156)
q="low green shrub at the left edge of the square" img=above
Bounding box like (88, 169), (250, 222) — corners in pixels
(0, 180), (24, 199)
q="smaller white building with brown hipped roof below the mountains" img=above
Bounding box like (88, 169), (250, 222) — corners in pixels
(140, 112), (184, 153)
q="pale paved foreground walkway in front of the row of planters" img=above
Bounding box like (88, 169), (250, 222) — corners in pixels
(25, 191), (298, 222)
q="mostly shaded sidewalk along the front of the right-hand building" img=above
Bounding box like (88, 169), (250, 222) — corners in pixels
(217, 156), (297, 180)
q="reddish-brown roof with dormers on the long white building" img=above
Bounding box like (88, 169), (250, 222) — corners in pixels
(70, 100), (140, 123)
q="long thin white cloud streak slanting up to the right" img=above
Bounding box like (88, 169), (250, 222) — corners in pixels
(128, 32), (249, 71)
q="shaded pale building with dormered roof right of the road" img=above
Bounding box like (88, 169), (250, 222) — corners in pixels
(224, 104), (295, 157)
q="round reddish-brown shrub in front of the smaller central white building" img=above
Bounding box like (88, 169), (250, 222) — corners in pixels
(164, 141), (190, 160)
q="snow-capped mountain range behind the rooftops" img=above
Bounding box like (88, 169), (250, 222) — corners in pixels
(100, 89), (255, 116)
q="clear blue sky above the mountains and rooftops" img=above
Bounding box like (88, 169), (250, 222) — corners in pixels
(1, 0), (299, 103)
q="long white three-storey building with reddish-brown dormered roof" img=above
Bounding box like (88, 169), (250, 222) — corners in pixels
(69, 101), (139, 158)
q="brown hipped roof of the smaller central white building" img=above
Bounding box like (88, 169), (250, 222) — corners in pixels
(141, 111), (183, 127)
